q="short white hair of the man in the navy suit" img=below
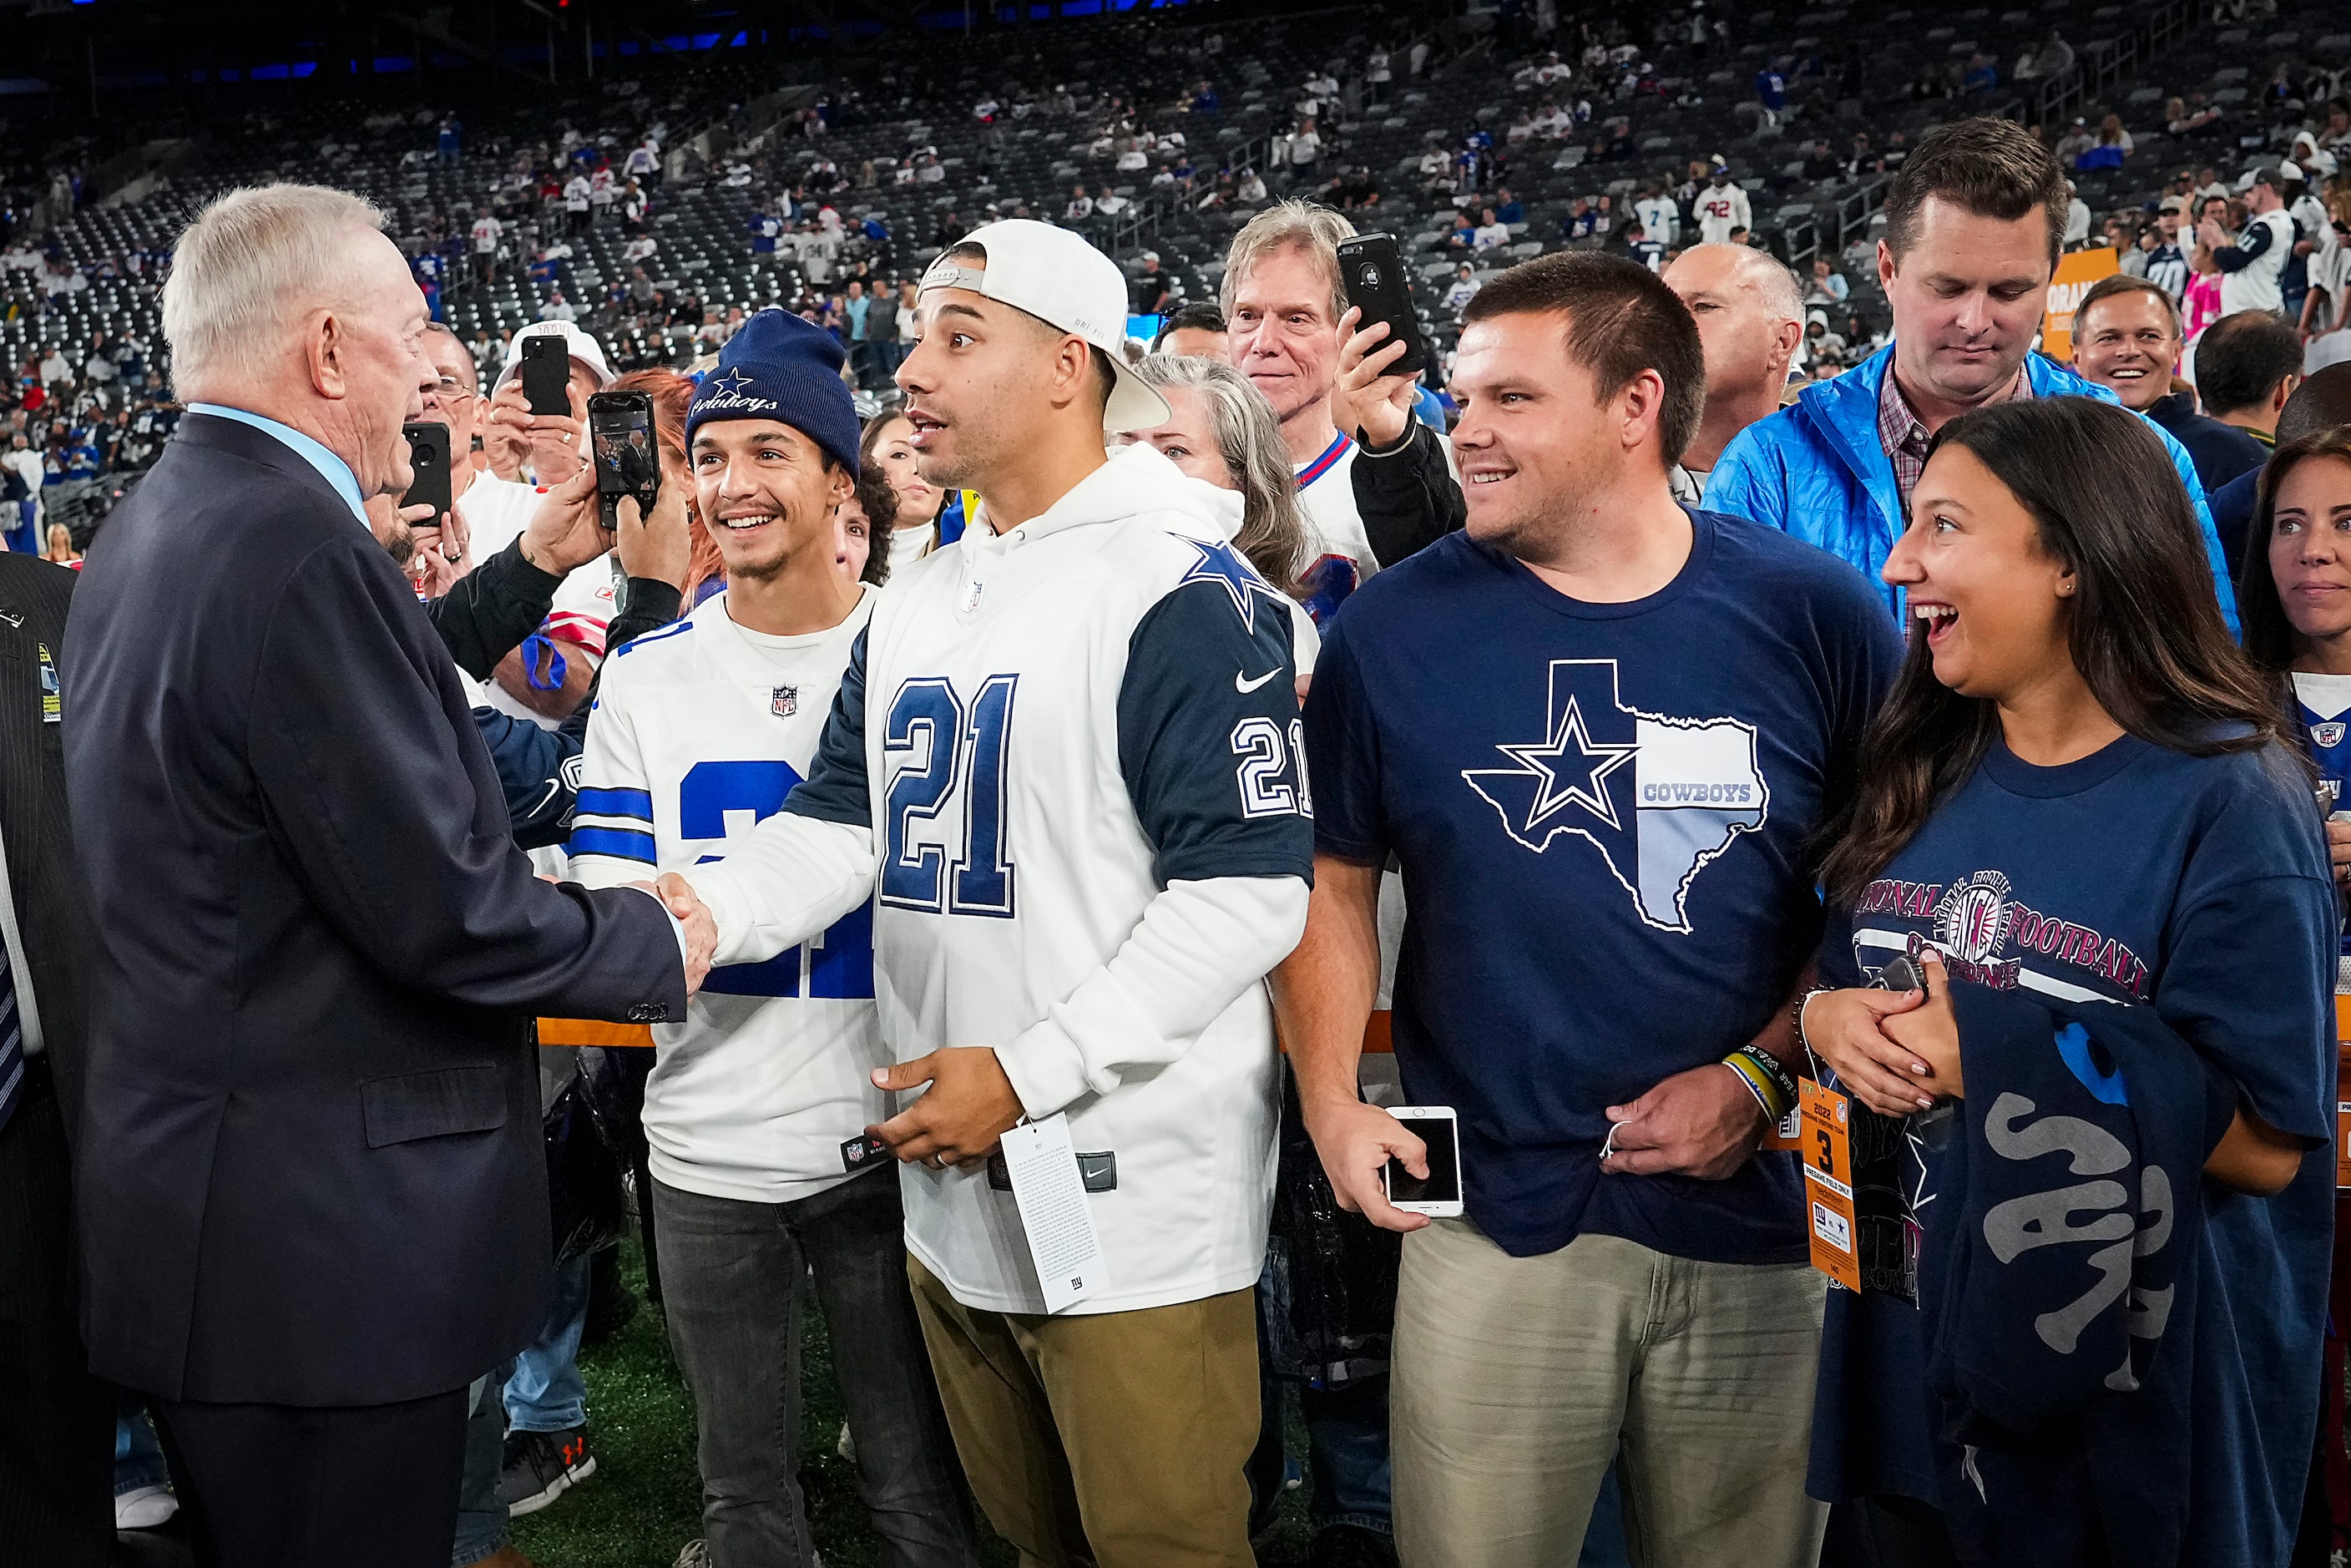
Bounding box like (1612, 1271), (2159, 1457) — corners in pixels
(162, 185), (383, 400)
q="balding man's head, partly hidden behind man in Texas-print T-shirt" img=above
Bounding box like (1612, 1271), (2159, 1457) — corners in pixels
(1665, 245), (1803, 491)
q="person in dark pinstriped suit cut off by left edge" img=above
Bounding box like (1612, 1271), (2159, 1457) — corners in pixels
(0, 554), (115, 1568)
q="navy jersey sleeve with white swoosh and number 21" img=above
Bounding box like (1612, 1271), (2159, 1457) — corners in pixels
(1119, 567), (1314, 886)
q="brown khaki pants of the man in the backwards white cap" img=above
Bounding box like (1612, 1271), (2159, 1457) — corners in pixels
(905, 1257), (1258, 1568)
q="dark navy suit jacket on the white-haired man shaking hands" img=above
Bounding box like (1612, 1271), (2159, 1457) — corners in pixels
(63, 414), (684, 1406)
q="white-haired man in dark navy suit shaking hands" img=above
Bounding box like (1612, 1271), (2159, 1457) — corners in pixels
(63, 185), (712, 1568)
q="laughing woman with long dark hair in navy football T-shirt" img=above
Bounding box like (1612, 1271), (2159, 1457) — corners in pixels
(1798, 397), (2337, 1565)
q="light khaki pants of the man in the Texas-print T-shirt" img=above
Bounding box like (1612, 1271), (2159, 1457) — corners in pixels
(1389, 1220), (1827, 1568)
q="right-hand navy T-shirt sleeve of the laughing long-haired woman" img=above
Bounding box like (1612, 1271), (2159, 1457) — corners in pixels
(2156, 750), (2339, 1142)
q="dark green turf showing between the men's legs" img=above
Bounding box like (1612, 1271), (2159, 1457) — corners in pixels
(515, 1239), (1305, 1568)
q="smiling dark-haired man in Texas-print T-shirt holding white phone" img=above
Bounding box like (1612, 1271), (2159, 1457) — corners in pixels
(1274, 251), (1899, 1568)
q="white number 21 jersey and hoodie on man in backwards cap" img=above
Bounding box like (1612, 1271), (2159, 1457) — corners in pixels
(694, 444), (1312, 1312)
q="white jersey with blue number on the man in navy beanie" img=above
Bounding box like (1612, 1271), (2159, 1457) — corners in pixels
(569, 590), (891, 1204)
